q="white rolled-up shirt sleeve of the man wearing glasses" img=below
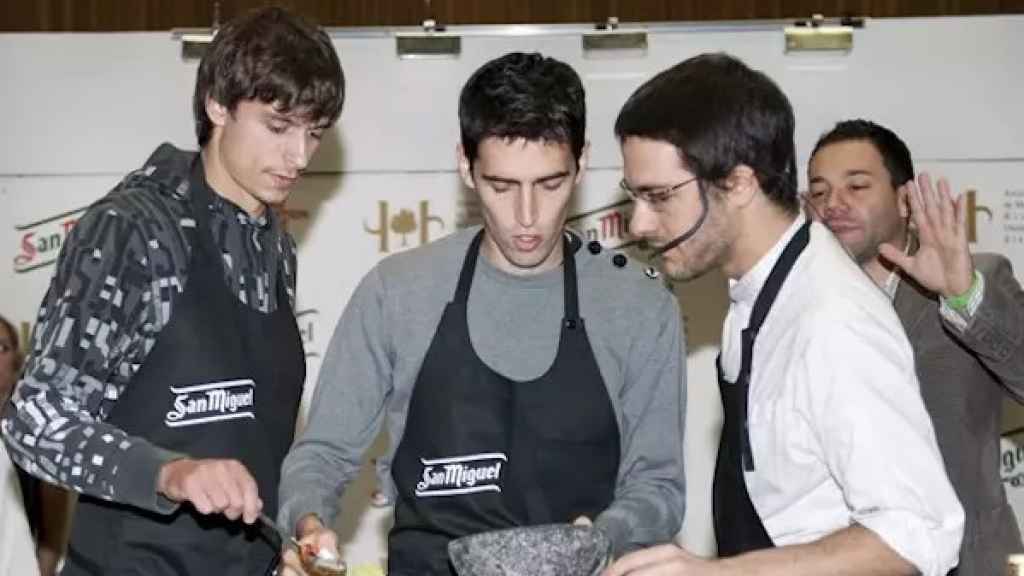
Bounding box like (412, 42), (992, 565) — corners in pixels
(806, 318), (965, 576)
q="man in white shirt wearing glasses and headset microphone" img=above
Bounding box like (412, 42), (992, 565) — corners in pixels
(607, 54), (964, 576)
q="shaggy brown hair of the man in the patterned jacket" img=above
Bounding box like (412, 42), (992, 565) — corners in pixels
(193, 7), (345, 147)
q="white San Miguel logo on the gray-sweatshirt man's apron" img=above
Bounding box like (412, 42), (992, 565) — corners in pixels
(416, 452), (509, 498)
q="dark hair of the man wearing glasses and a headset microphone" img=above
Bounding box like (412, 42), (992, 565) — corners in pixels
(615, 53), (800, 212)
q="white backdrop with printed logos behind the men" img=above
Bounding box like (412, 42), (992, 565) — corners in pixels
(0, 16), (1024, 567)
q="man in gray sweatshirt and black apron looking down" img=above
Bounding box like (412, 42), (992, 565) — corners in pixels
(279, 53), (685, 576)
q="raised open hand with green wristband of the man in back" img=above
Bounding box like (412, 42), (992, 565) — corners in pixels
(879, 172), (974, 298)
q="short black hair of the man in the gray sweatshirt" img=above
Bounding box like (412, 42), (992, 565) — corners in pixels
(459, 52), (587, 164)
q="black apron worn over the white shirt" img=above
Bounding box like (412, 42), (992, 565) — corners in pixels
(713, 222), (810, 558)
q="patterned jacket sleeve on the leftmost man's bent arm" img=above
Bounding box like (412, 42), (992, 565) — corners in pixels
(2, 202), (184, 511)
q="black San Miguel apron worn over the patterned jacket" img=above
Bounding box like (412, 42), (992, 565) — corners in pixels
(61, 159), (305, 576)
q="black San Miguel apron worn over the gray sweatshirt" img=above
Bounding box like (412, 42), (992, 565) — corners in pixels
(388, 232), (620, 576)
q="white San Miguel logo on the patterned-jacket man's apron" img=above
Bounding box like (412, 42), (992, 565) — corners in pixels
(164, 378), (256, 428)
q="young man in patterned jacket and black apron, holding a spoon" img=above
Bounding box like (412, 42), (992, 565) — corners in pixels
(2, 8), (344, 576)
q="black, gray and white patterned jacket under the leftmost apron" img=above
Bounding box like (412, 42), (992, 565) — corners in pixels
(0, 143), (296, 510)
